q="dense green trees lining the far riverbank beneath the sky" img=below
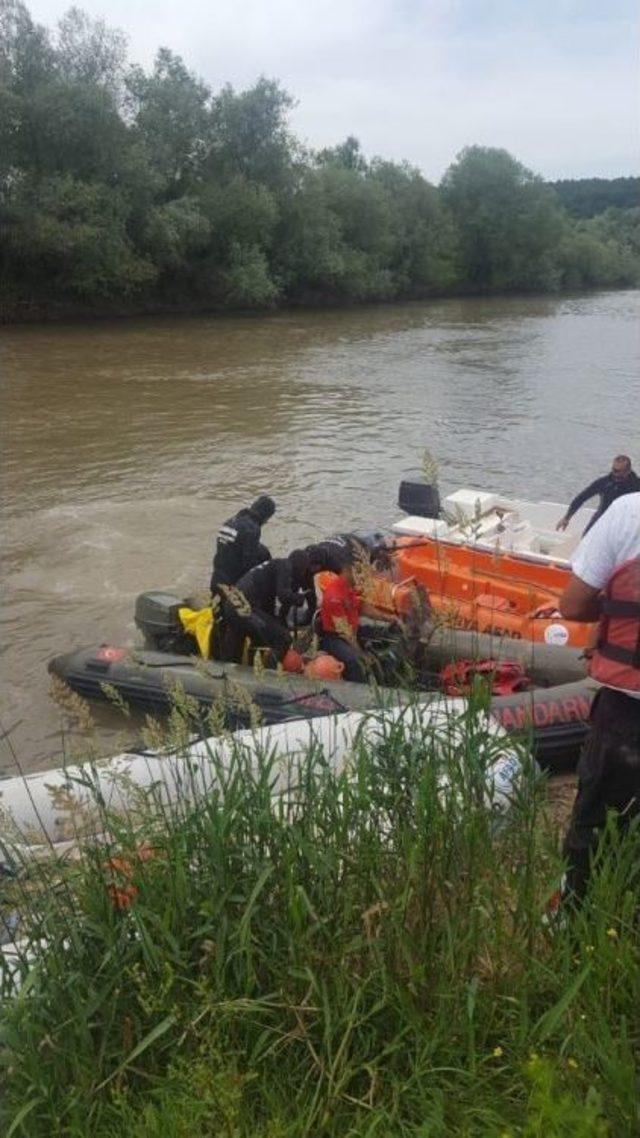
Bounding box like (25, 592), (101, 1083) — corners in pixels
(0, 0), (640, 311)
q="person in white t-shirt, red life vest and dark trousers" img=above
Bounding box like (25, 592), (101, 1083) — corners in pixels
(559, 493), (640, 899)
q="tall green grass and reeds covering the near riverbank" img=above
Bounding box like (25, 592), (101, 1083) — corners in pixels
(1, 707), (640, 1138)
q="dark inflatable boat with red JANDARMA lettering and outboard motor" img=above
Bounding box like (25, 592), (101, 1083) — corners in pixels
(49, 593), (597, 769)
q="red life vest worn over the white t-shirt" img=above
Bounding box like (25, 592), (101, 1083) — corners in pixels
(589, 556), (640, 692)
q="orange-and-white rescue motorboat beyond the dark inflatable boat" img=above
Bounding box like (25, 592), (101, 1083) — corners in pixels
(364, 487), (593, 648)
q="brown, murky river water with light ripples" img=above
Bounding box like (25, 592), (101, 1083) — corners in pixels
(0, 291), (640, 773)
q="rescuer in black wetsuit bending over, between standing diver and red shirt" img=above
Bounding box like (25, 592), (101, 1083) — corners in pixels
(217, 550), (313, 662)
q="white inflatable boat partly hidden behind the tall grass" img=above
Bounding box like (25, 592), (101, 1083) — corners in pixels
(0, 699), (522, 996)
